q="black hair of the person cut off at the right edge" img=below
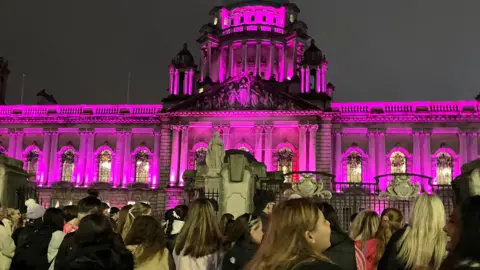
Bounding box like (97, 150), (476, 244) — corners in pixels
(453, 196), (480, 262)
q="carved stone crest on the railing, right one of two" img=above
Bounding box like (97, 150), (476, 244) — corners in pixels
(381, 175), (420, 200)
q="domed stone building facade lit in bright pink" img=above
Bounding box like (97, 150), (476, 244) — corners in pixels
(0, 0), (480, 213)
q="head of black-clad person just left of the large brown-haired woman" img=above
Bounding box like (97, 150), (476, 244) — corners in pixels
(227, 214), (263, 244)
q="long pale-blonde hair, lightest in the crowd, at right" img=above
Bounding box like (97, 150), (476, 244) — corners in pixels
(397, 193), (447, 269)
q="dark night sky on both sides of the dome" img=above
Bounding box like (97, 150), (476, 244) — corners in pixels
(0, 0), (480, 104)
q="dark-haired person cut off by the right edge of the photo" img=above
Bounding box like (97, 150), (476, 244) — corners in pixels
(440, 195), (480, 270)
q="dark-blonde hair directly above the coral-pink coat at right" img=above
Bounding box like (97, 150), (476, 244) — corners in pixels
(348, 210), (380, 241)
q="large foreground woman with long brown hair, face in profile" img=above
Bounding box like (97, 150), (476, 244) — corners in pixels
(245, 199), (341, 270)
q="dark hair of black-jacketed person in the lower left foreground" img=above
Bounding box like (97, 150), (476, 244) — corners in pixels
(75, 213), (114, 247)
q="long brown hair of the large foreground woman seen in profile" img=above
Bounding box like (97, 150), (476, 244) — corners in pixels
(245, 199), (329, 270)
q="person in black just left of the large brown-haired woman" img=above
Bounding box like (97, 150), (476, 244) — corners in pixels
(222, 214), (263, 270)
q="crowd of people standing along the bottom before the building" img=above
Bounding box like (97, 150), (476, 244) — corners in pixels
(0, 188), (474, 270)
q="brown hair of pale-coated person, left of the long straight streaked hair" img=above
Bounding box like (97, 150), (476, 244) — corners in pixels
(125, 216), (166, 265)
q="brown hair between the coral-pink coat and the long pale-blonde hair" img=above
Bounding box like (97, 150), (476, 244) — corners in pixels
(374, 208), (403, 266)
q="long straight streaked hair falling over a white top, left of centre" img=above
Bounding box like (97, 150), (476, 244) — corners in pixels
(174, 199), (223, 258)
